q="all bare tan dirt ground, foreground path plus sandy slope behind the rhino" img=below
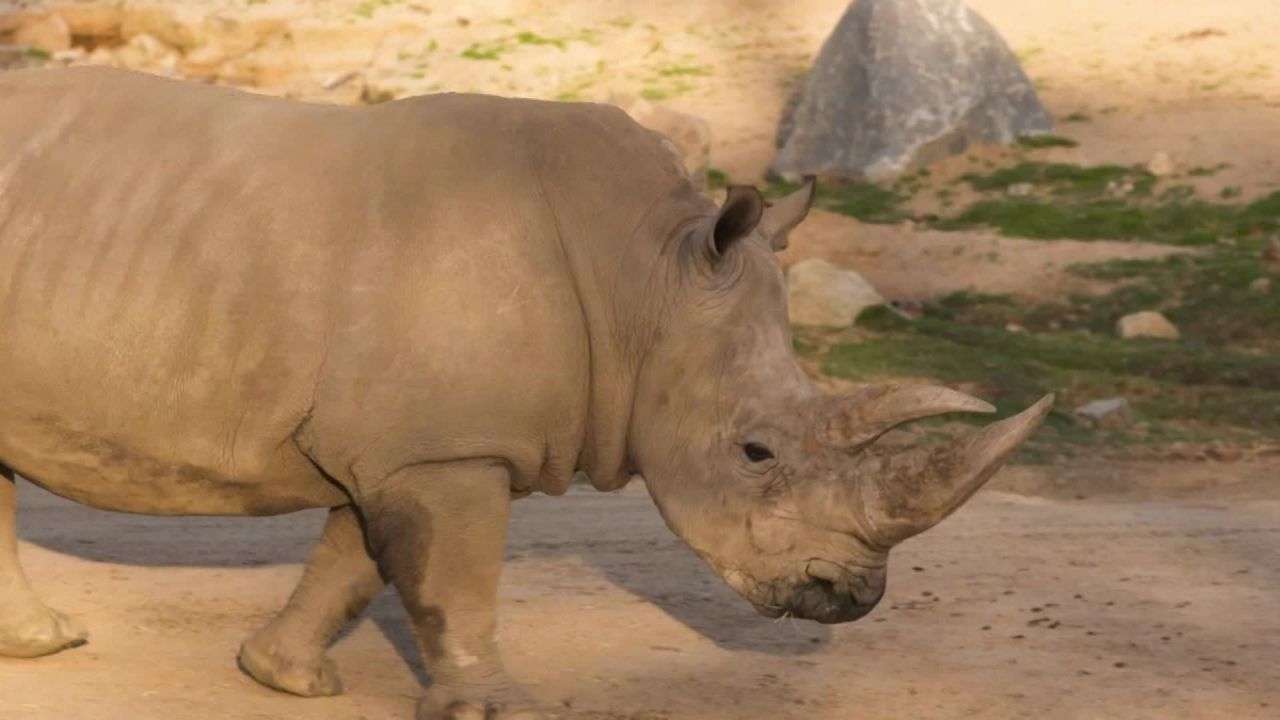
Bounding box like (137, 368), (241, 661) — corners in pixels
(0, 0), (1280, 720)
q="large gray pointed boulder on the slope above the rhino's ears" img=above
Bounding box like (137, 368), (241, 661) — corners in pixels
(771, 0), (1052, 179)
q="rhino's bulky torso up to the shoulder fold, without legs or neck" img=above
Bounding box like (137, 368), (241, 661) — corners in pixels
(0, 69), (609, 514)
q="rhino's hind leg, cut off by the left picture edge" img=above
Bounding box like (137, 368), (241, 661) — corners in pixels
(0, 465), (88, 657)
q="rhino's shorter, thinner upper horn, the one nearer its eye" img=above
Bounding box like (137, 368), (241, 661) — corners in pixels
(814, 384), (996, 450)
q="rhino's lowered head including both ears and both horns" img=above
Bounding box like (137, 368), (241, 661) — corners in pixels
(630, 181), (1052, 623)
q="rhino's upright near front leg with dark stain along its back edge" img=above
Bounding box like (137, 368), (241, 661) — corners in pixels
(362, 461), (543, 720)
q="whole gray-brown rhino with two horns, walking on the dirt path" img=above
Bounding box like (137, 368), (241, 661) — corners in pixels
(0, 69), (1048, 720)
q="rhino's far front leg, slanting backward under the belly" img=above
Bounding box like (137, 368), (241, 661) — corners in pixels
(239, 505), (385, 697)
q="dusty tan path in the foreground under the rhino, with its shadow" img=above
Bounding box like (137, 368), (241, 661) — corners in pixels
(0, 474), (1280, 720)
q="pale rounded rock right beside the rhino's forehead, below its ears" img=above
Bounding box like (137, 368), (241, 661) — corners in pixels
(787, 258), (884, 328)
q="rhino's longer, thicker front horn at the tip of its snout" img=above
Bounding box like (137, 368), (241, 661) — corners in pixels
(861, 395), (1053, 547)
